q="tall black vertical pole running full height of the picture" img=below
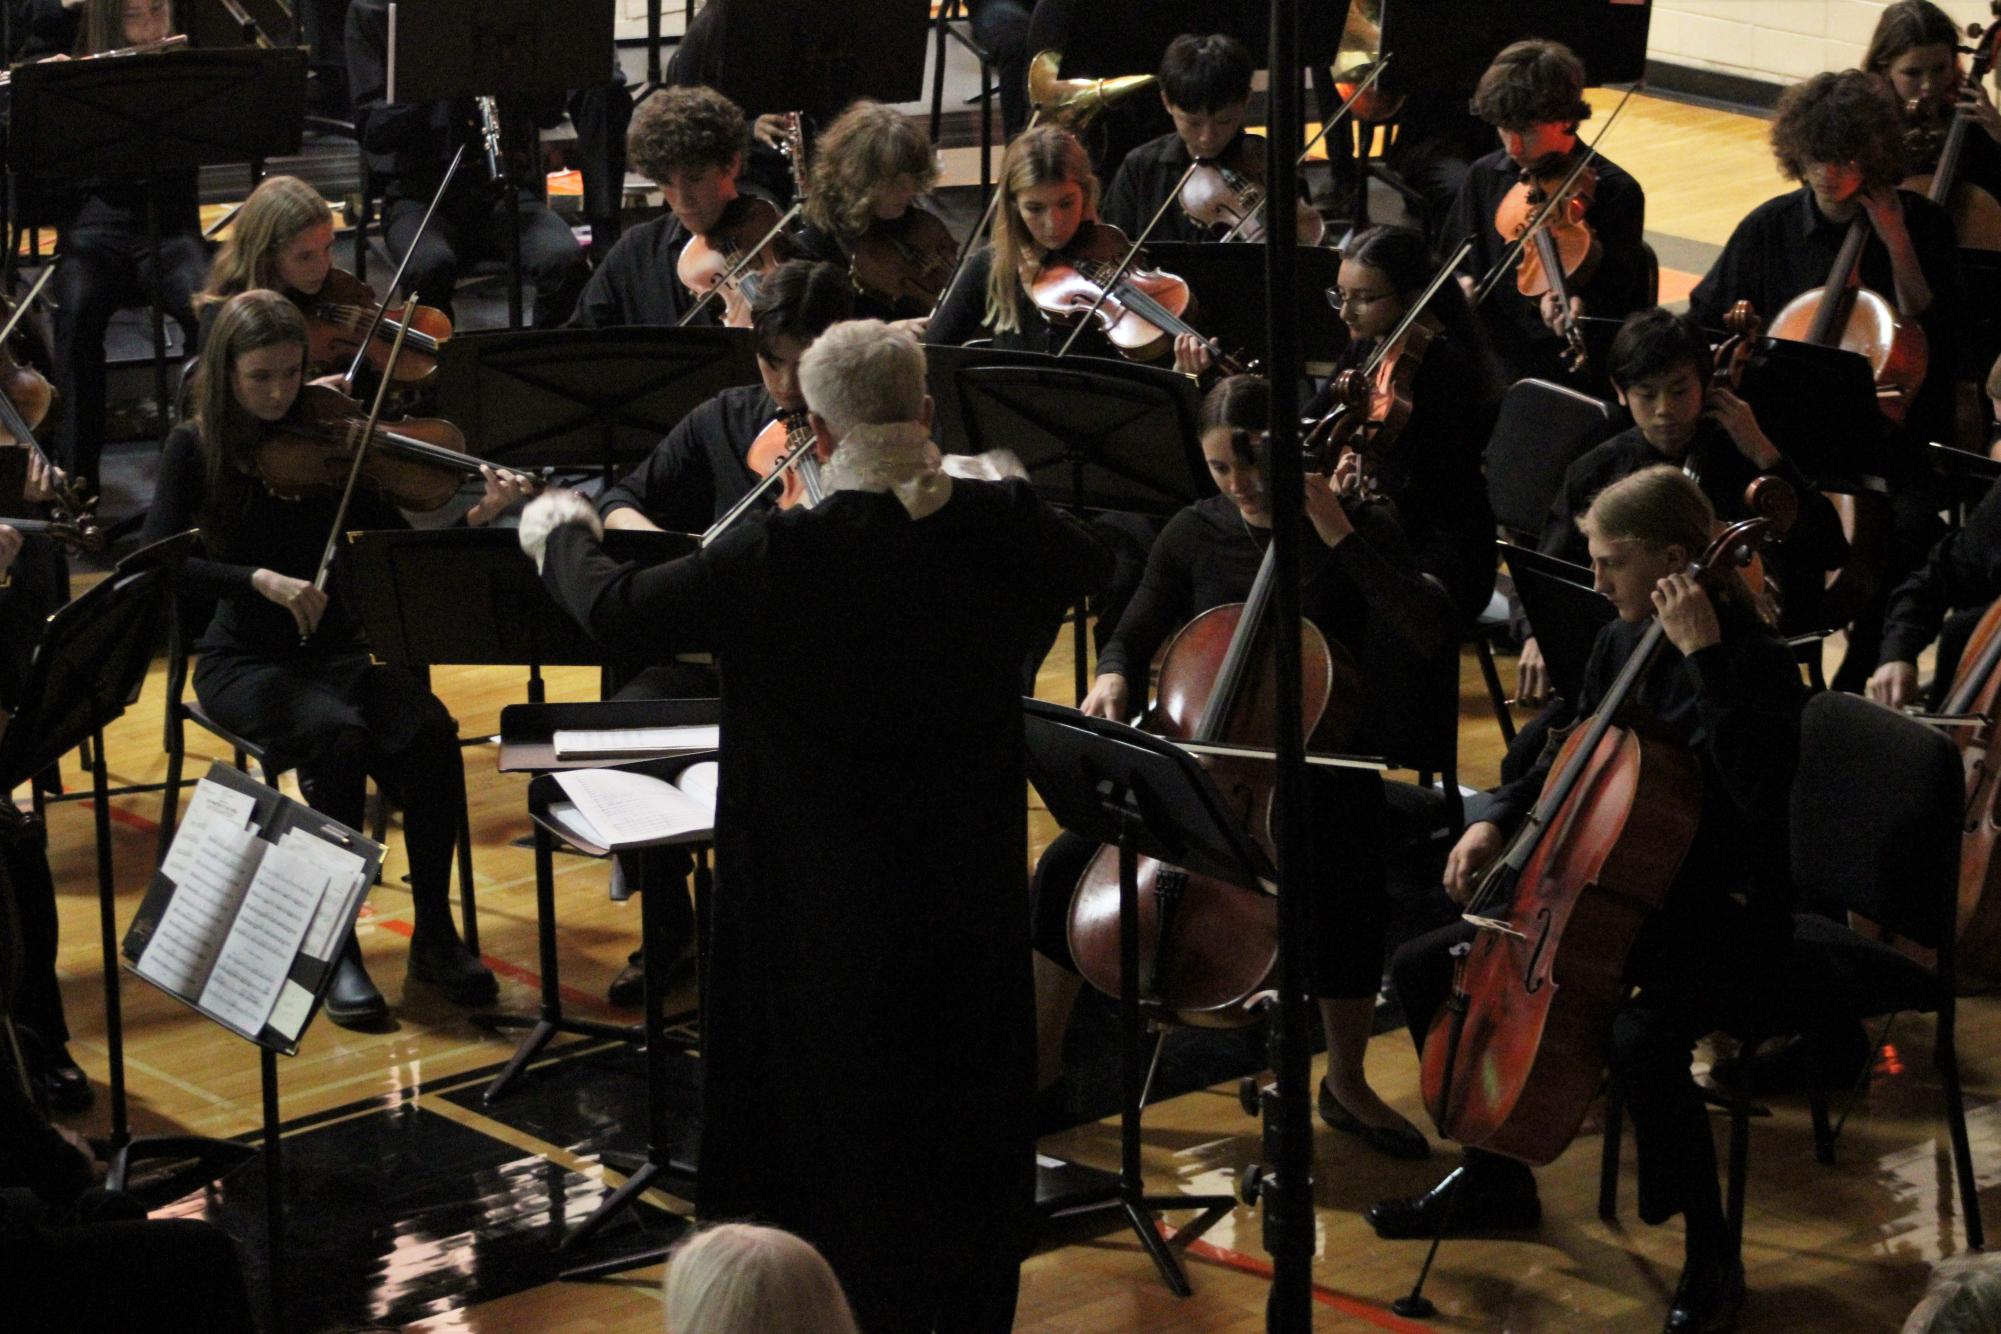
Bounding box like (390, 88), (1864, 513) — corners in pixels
(1257, 0), (1325, 1334)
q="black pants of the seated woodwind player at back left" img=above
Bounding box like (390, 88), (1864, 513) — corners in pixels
(382, 188), (590, 328)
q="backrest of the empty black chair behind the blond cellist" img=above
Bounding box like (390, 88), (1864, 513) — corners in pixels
(1791, 692), (1965, 960)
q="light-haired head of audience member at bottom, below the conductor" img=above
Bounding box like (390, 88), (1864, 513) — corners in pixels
(660, 1222), (856, 1334)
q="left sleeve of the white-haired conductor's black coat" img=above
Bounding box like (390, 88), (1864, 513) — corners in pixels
(542, 524), (732, 656)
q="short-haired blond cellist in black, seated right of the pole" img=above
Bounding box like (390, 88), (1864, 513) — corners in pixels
(1367, 466), (1805, 1330)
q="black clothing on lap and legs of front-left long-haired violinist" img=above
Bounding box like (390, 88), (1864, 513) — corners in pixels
(194, 648), (466, 930)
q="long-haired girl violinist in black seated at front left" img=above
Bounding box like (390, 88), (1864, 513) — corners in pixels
(146, 292), (522, 1028)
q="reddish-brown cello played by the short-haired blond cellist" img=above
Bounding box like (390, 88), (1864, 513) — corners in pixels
(1423, 518), (1773, 1164)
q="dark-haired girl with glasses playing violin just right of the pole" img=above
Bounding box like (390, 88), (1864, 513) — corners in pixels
(1307, 226), (1499, 622)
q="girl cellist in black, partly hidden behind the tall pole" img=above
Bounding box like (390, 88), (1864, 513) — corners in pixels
(1033, 376), (1457, 1158)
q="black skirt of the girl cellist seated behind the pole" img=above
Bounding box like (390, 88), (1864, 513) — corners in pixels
(1029, 770), (1391, 1000)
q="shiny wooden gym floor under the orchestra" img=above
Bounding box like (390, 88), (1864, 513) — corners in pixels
(31, 88), (2001, 1334)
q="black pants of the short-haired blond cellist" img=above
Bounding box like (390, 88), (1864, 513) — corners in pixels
(1389, 908), (1773, 1224)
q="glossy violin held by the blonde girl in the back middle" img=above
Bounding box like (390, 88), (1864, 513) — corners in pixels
(1021, 222), (1245, 374)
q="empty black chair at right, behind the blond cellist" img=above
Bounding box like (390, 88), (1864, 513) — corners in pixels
(1599, 692), (1985, 1250)
